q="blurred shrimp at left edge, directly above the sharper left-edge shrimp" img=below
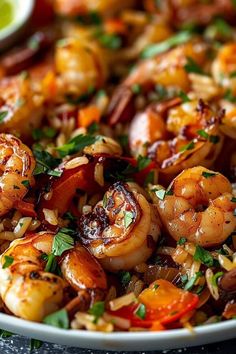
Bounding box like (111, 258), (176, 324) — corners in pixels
(0, 75), (44, 138)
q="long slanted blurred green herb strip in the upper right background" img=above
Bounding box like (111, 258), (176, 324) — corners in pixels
(141, 31), (193, 58)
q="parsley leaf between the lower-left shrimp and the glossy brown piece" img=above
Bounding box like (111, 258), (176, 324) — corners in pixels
(52, 229), (74, 256)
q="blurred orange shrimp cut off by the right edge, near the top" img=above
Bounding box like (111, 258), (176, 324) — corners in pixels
(212, 43), (236, 94)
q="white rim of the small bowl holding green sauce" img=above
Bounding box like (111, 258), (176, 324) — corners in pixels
(0, 0), (35, 50)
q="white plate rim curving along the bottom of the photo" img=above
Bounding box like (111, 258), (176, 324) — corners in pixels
(0, 314), (236, 351)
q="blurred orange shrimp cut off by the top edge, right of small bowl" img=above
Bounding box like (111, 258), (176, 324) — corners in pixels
(54, 0), (135, 16)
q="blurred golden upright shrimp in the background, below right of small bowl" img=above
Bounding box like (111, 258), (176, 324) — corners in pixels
(55, 38), (106, 95)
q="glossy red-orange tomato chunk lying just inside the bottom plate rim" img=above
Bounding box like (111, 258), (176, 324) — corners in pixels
(111, 279), (198, 330)
